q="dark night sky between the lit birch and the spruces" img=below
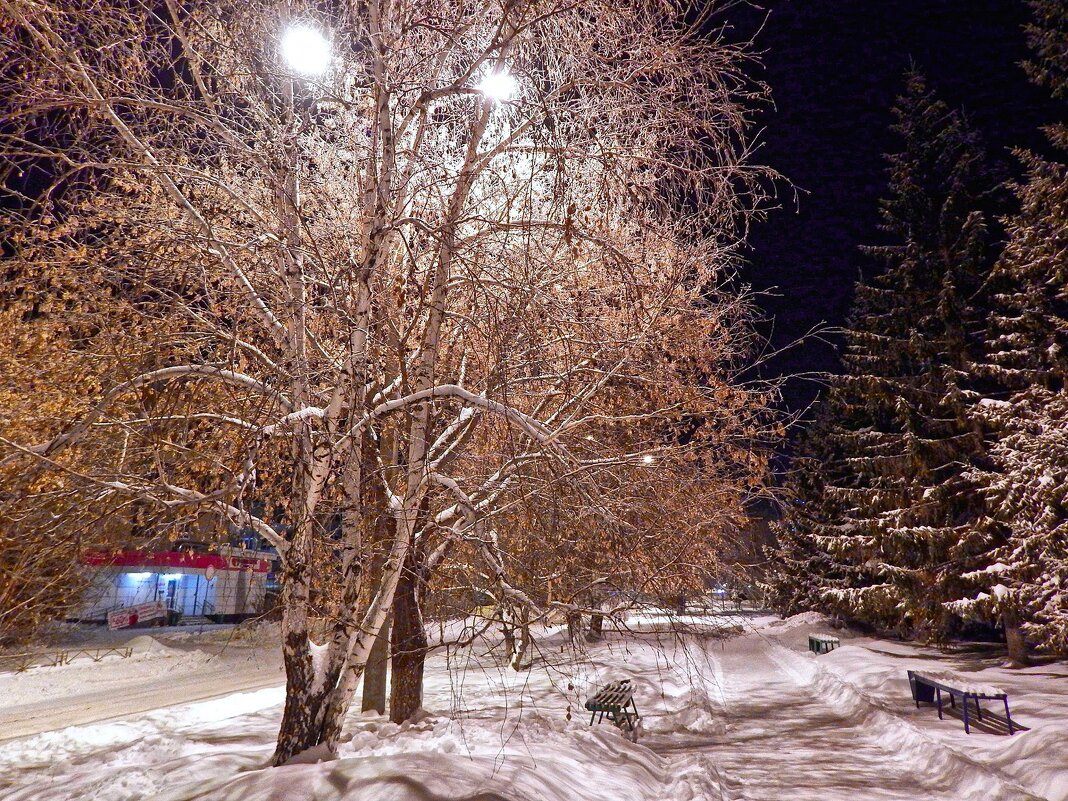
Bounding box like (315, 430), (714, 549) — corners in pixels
(727, 0), (1055, 409)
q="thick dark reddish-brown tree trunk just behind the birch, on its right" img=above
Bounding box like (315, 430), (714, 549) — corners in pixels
(390, 548), (428, 723)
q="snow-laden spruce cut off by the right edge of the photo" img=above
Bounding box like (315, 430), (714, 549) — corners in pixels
(953, 0), (1068, 662)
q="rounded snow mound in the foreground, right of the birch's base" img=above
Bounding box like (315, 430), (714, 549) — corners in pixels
(175, 720), (723, 801)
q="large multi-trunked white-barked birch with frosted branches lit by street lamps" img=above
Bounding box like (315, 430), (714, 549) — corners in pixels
(0, 0), (767, 764)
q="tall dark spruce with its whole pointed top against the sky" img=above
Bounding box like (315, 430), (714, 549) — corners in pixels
(773, 74), (995, 639)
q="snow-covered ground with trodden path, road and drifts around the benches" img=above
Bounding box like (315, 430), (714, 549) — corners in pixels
(0, 614), (1068, 801)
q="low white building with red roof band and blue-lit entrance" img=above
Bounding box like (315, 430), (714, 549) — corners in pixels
(77, 546), (277, 623)
